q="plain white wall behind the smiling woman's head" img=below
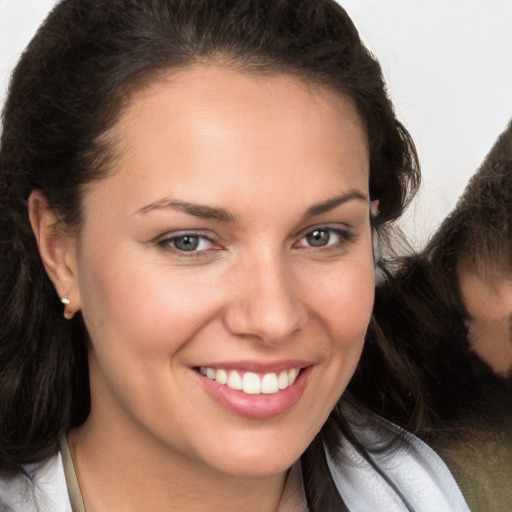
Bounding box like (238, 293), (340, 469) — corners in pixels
(0, 0), (512, 246)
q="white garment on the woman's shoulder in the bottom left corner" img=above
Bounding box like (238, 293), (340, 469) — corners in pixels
(0, 454), (71, 512)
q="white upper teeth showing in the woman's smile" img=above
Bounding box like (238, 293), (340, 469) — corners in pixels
(199, 366), (300, 395)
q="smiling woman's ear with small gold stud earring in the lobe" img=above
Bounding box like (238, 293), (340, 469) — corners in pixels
(28, 190), (80, 319)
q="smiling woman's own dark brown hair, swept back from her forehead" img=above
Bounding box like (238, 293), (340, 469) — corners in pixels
(0, 0), (419, 512)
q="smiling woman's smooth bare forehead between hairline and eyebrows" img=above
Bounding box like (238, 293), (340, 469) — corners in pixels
(85, 65), (369, 217)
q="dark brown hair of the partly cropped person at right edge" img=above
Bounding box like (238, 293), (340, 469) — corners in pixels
(350, 121), (512, 440)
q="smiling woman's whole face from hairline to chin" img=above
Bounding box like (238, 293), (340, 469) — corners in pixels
(70, 66), (374, 475)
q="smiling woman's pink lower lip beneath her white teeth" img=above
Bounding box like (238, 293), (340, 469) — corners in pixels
(195, 366), (312, 419)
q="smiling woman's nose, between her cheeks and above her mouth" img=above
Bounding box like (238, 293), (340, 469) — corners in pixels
(224, 251), (306, 344)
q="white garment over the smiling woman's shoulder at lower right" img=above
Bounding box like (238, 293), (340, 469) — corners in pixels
(329, 405), (469, 512)
